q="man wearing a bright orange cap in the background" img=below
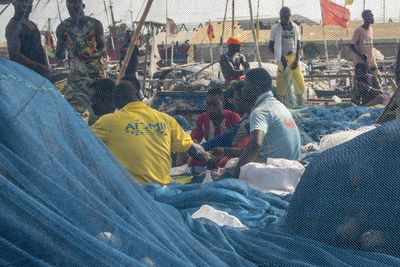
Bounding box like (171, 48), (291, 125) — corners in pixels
(220, 36), (250, 85)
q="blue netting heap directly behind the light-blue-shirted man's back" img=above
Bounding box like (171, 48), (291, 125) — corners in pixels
(292, 106), (383, 145)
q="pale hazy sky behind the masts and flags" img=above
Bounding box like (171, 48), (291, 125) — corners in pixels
(0, 0), (400, 42)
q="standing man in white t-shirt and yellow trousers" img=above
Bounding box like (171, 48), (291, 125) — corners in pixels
(269, 7), (306, 106)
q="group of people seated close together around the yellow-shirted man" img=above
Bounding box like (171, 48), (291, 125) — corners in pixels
(90, 68), (301, 184)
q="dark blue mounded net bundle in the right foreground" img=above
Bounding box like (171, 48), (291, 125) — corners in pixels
(286, 116), (400, 257)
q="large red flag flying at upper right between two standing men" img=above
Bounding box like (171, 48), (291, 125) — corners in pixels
(321, 0), (350, 28)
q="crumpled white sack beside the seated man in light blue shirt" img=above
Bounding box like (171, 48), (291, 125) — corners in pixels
(239, 158), (305, 196)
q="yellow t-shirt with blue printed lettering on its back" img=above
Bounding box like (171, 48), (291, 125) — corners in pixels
(92, 102), (193, 185)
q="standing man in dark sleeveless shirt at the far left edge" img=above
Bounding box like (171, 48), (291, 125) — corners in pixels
(6, 0), (49, 77)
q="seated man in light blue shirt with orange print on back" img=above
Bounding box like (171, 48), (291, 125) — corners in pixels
(232, 68), (301, 177)
